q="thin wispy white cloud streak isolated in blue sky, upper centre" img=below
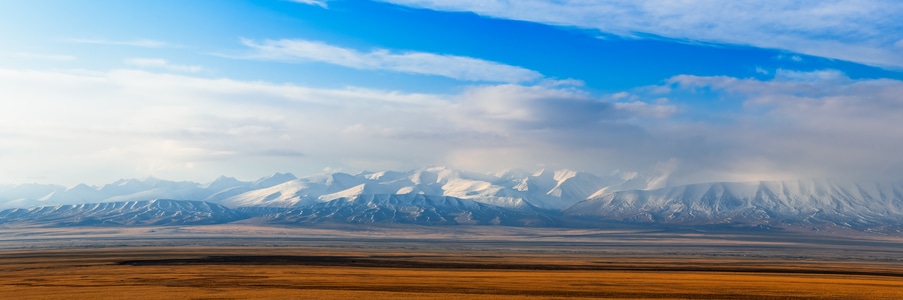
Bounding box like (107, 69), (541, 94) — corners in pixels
(242, 39), (542, 82)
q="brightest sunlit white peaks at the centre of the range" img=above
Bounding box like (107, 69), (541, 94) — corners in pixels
(222, 167), (626, 210)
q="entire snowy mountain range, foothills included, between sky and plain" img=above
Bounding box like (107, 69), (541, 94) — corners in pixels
(0, 167), (903, 234)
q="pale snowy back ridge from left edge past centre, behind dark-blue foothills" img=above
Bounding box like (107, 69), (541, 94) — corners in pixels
(0, 167), (676, 210)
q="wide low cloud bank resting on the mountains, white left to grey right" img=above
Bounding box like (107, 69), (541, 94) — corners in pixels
(0, 69), (903, 183)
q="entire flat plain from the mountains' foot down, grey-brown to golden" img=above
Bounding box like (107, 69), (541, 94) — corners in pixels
(0, 225), (903, 299)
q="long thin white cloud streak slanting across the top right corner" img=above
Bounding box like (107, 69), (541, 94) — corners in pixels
(383, 0), (903, 67)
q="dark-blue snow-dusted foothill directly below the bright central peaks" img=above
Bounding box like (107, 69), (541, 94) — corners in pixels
(251, 194), (555, 226)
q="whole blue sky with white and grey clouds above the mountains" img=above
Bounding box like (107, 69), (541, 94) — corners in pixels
(0, 0), (903, 185)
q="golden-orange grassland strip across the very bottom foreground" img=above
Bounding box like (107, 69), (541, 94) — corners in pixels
(0, 246), (903, 299)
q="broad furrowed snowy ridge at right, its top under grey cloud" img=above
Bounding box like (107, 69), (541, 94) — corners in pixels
(564, 180), (903, 229)
